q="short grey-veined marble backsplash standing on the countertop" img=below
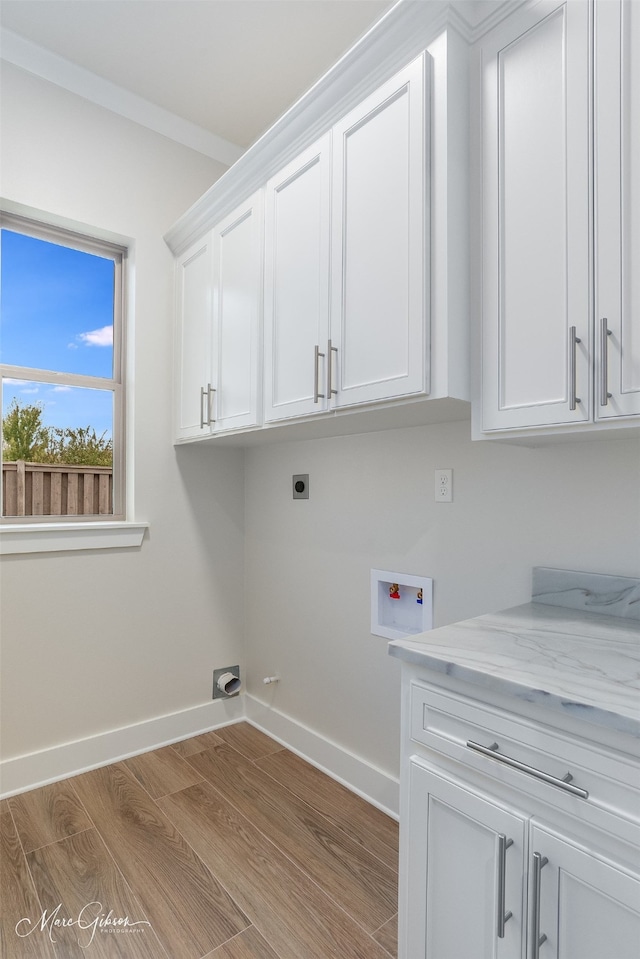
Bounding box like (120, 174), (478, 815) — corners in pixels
(531, 566), (640, 621)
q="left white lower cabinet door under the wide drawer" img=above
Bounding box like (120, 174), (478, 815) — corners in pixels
(399, 762), (526, 959)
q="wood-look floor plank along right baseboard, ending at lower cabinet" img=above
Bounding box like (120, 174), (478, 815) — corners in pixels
(256, 749), (398, 872)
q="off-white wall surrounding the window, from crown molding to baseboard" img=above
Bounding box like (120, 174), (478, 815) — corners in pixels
(0, 67), (244, 772)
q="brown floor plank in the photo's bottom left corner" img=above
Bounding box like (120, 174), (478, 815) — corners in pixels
(0, 800), (56, 959)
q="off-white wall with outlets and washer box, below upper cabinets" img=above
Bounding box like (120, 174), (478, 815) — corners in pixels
(245, 423), (640, 776)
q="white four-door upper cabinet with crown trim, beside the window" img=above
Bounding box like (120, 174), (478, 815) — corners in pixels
(165, 3), (470, 444)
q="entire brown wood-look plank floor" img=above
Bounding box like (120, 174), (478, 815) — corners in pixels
(0, 723), (398, 959)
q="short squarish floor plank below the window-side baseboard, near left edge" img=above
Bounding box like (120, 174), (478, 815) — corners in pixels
(8, 782), (93, 853)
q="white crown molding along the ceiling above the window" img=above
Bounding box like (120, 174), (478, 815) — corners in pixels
(0, 29), (244, 166)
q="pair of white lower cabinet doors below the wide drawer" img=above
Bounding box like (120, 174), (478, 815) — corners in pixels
(400, 760), (640, 959)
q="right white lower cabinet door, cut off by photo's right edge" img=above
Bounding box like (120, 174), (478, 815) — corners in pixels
(529, 826), (640, 959)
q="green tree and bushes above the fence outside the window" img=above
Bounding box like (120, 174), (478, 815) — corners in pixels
(2, 399), (113, 466)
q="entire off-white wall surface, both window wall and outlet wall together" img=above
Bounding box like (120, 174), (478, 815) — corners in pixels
(1, 62), (640, 808)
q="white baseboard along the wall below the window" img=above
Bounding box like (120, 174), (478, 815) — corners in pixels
(0, 696), (244, 799)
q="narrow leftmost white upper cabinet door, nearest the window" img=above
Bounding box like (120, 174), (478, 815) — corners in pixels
(174, 233), (213, 440)
